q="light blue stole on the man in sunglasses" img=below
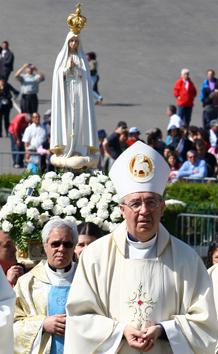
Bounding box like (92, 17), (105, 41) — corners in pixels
(48, 285), (70, 354)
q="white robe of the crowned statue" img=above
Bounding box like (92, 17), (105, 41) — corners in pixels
(50, 32), (98, 158)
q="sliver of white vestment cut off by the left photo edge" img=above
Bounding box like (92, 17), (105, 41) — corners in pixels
(0, 266), (15, 354)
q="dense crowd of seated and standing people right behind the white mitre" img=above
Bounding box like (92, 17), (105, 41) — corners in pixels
(98, 115), (218, 183)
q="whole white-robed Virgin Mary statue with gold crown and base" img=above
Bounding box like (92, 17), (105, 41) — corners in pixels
(50, 5), (98, 169)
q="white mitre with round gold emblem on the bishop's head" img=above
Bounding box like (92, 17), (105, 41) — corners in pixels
(109, 141), (170, 198)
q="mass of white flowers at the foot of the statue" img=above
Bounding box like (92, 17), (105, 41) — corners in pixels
(0, 171), (122, 250)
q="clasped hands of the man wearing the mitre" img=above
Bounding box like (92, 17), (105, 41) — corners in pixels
(123, 325), (162, 352)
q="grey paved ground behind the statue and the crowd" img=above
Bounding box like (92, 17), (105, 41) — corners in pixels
(0, 0), (218, 172)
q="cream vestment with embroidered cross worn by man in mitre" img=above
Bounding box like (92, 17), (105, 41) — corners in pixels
(64, 221), (218, 354)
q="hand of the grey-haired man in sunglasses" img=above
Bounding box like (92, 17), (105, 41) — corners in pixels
(43, 314), (66, 336)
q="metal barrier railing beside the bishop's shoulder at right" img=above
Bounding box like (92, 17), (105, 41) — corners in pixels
(177, 213), (218, 258)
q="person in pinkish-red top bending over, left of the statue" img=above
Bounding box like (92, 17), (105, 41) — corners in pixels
(8, 113), (30, 168)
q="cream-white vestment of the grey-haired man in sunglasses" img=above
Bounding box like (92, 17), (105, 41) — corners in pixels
(14, 261), (76, 354)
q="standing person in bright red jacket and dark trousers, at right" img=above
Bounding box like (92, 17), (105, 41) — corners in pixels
(173, 69), (197, 127)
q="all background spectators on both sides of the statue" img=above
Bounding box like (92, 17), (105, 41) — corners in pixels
(0, 41), (218, 183)
